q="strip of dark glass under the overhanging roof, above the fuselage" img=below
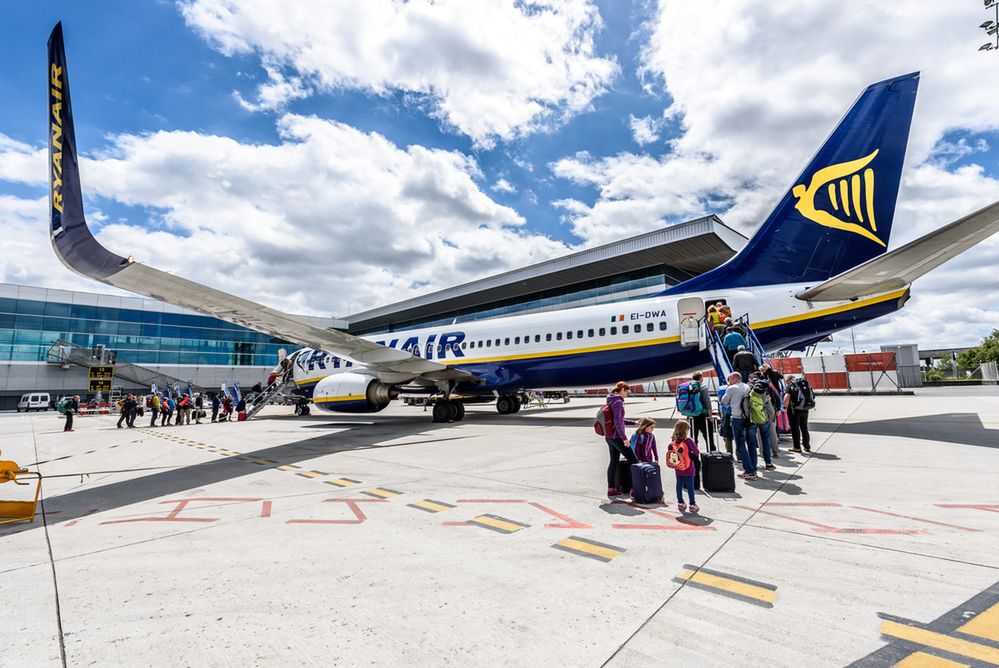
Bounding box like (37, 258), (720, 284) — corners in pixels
(372, 265), (693, 333)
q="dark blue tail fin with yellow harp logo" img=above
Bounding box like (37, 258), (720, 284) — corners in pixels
(663, 72), (919, 294)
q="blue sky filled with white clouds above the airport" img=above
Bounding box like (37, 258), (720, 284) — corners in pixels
(0, 0), (999, 350)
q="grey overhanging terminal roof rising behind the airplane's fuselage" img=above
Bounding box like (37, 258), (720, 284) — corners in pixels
(346, 215), (747, 331)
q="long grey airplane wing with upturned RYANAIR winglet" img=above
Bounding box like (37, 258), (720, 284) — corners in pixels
(46, 23), (474, 380)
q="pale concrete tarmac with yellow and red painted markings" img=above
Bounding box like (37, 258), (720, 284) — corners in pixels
(0, 388), (999, 668)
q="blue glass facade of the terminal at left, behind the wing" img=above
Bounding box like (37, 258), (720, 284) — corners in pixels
(0, 290), (298, 366)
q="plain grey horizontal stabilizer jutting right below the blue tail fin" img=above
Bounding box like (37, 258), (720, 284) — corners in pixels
(795, 202), (999, 301)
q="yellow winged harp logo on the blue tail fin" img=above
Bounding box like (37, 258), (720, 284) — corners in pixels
(791, 149), (888, 248)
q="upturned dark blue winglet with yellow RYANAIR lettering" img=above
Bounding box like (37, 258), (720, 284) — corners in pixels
(45, 21), (131, 282)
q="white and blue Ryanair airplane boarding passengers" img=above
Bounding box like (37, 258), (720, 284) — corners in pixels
(46, 23), (999, 422)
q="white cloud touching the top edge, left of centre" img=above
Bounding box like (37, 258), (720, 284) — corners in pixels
(180, 0), (618, 146)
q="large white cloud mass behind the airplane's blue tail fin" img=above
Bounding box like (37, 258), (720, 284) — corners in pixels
(550, 0), (999, 344)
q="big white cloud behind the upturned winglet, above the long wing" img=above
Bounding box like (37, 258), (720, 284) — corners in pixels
(0, 115), (567, 315)
